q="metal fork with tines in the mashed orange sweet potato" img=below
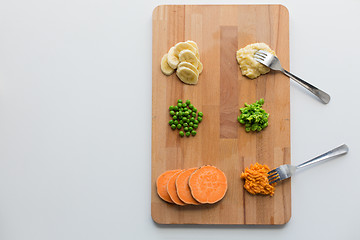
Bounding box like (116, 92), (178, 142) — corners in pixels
(268, 144), (349, 184)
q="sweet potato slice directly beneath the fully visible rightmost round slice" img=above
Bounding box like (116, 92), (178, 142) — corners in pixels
(175, 167), (200, 205)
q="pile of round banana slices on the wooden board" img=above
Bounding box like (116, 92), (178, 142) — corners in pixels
(161, 40), (203, 84)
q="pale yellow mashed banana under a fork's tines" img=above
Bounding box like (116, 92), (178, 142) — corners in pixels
(236, 43), (276, 79)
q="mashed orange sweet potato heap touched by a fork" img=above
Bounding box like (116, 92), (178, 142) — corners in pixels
(241, 163), (276, 196)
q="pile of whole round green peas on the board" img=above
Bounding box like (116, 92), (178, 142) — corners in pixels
(169, 99), (203, 137)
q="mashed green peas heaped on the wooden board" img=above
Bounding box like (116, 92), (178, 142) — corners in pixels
(237, 98), (269, 132)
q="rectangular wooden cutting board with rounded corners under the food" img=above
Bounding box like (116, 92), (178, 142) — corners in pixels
(151, 5), (291, 224)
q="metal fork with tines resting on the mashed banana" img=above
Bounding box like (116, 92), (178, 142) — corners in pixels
(254, 50), (330, 104)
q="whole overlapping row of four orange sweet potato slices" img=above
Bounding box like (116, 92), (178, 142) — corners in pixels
(156, 165), (227, 206)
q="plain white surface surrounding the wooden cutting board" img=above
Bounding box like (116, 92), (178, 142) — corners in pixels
(0, 0), (360, 240)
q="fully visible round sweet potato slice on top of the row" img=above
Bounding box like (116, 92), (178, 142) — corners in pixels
(189, 165), (227, 203)
